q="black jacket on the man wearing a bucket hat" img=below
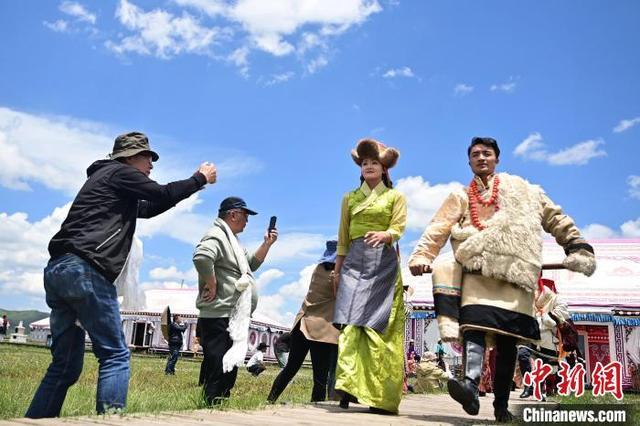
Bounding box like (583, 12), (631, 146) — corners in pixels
(49, 160), (207, 282)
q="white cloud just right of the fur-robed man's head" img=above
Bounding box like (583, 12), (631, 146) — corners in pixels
(513, 132), (607, 166)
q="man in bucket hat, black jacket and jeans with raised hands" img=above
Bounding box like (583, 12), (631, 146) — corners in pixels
(26, 132), (216, 418)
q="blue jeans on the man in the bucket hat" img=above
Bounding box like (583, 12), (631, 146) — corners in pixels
(25, 254), (129, 418)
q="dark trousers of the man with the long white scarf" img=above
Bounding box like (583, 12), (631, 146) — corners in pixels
(199, 318), (238, 404)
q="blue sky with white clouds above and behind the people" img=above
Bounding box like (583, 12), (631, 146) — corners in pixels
(0, 0), (640, 322)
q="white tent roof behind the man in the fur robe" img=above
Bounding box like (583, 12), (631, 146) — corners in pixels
(402, 239), (640, 312)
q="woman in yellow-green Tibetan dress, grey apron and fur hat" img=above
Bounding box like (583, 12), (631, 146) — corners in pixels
(333, 139), (407, 413)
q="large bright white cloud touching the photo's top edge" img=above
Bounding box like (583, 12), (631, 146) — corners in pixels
(106, 0), (382, 73)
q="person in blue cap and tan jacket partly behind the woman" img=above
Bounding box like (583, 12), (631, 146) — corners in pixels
(267, 240), (339, 403)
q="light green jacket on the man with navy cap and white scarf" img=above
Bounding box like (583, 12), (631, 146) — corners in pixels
(193, 218), (262, 318)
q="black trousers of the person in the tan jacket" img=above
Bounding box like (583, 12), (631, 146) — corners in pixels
(268, 325), (338, 402)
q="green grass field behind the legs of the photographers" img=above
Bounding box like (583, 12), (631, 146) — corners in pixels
(0, 343), (312, 419)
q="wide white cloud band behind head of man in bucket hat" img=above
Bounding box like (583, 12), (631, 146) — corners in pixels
(0, 106), (264, 195)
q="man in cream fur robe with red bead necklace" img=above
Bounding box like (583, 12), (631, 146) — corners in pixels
(409, 138), (595, 422)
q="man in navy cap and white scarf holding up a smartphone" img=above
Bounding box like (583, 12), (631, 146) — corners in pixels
(193, 197), (278, 405)
